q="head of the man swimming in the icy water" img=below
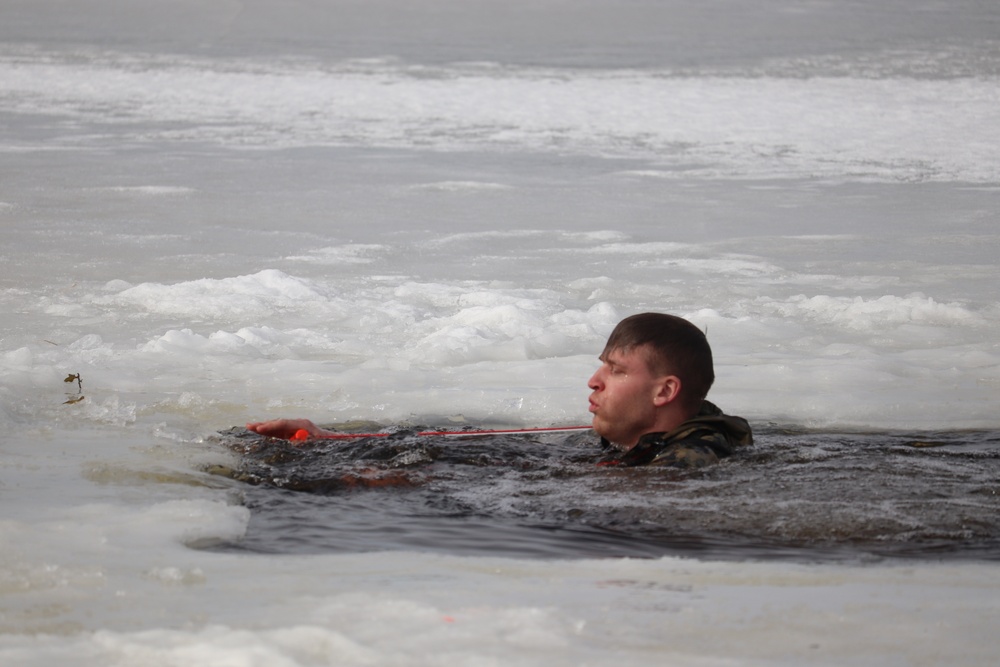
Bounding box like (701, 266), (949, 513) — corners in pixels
(588, 313), (715, 447)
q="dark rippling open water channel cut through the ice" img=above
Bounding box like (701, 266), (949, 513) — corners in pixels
(207, 427), (1000, 561)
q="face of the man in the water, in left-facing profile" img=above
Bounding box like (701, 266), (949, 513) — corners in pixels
(587, 348), (663, 447)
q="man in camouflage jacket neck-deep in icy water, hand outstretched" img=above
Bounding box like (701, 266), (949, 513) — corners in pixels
(247, 313), (753, 468)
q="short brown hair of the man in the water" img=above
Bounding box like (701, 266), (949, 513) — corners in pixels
(601, 313), (715, 410)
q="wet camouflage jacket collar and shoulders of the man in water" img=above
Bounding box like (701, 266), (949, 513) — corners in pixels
(599, 401), (753, 468)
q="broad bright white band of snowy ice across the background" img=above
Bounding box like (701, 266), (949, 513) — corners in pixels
(0, 53), (1000, 181)
